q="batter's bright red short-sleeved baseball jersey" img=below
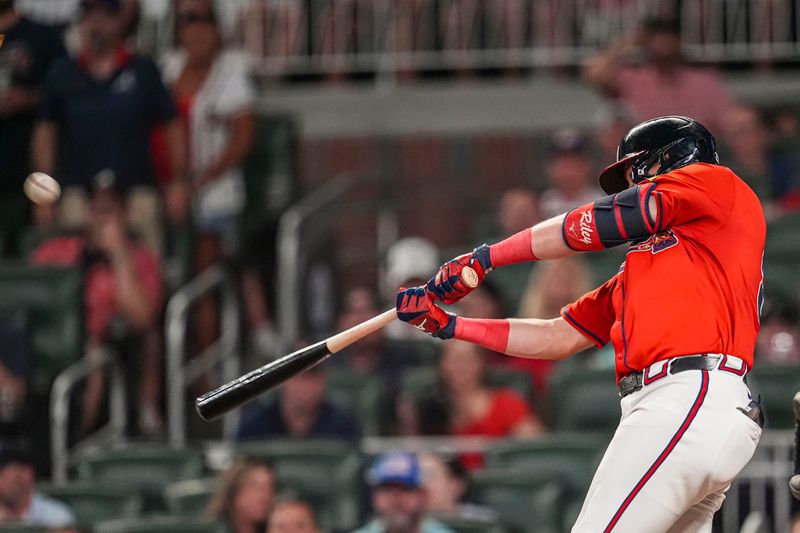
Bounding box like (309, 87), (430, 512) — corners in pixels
(561, 163), (766, 380)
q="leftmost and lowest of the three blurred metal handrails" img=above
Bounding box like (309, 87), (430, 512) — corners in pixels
(50, 346), (128, 485)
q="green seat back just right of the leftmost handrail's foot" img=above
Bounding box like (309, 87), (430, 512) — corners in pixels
(78, 444), (205, 512)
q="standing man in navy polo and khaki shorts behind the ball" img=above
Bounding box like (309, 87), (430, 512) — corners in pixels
(33, 0), (185, 253)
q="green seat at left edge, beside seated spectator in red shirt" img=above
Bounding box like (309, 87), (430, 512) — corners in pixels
(0, 262), (83, 392)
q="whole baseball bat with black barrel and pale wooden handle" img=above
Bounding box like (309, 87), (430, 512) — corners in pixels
(195, 266), (478, 420)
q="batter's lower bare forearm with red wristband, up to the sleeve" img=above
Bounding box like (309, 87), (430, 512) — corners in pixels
(453, 317), (591, 359)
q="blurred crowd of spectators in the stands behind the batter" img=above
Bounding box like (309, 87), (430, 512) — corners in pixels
(0, 0), (800, 533)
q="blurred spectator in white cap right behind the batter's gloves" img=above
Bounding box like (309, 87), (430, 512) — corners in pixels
(381, 237), (442, 342)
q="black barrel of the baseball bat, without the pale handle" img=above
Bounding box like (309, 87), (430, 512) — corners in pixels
(194, 341), (331, 420)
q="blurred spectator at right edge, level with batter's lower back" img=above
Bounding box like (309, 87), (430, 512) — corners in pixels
(756, 295), (800, 365)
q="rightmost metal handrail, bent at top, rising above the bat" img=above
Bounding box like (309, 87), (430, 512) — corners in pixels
(277, 174), (356, 348)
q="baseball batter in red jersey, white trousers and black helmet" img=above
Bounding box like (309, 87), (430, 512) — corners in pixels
(397, 116), (766, 533)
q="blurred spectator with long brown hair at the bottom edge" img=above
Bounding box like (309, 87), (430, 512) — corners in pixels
(206, 457), (277, 533)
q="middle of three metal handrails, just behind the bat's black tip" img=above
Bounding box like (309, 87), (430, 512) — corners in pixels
(164, 265), (240, 448)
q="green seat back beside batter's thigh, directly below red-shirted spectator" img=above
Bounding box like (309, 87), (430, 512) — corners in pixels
(484, 433), (609, 496)
